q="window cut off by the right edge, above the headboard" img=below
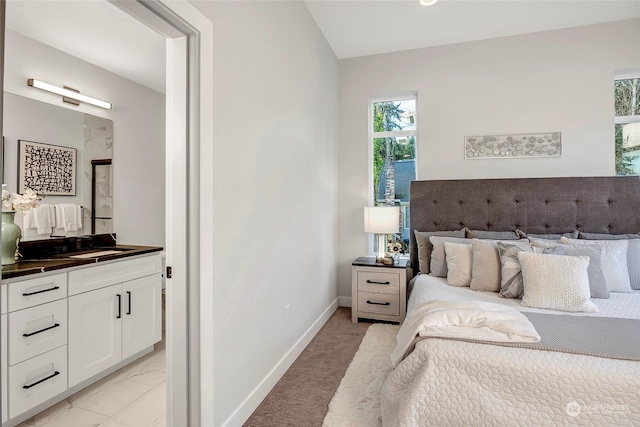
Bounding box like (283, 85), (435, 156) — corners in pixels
(614, 72), (640, 175)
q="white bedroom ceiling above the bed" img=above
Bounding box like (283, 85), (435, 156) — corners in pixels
(305, 0), (640, 59)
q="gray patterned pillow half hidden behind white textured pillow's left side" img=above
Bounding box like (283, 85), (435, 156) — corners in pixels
(497, 242), (564, 298)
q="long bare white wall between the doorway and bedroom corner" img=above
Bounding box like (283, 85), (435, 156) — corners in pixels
(194, 1), (338, 426)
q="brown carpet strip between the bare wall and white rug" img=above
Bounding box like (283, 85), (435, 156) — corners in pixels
(244, 307), (371, 427)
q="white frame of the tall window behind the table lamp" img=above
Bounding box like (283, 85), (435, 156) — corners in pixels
(367, 91), (420, 258)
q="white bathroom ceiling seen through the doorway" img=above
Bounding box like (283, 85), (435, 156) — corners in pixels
(6, 0), (165, 93)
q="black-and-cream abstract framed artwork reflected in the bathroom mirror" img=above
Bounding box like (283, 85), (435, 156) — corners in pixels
(18, 140), (77, 196)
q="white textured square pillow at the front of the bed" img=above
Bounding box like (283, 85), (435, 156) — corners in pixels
(518, 252), (598, 312)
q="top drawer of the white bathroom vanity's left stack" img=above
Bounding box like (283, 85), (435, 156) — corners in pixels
(7, 273), (67, 311)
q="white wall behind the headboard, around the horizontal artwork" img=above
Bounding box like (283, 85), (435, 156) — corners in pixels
(338, 19), (640, 297)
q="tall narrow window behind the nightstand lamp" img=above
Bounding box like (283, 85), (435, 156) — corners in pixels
(369, 96), (418, 254)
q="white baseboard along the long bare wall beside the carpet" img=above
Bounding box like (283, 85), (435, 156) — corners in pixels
(222, 298), (340, 427)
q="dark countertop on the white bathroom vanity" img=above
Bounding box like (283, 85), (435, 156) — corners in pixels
(2, 245), (163, 280)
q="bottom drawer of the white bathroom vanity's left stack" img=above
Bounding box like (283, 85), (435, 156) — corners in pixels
(9, 346), (67, 418)
